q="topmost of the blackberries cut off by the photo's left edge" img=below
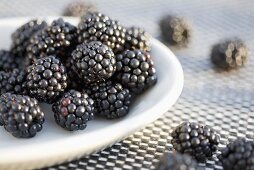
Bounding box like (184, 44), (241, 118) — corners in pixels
(0, 50), (19, 71)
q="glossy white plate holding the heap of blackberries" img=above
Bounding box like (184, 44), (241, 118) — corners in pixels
(0, 17), (183, 170)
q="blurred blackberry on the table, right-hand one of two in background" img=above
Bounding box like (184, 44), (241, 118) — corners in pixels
(211, 39), (248, 69)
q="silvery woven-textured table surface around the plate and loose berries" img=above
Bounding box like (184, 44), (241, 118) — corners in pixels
(0, 0), (254, 170)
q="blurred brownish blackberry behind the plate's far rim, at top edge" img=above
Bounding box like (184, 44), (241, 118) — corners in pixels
(63, 1), (97, 17)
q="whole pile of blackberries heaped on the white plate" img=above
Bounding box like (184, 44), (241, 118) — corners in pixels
(0, 12), (157, 138)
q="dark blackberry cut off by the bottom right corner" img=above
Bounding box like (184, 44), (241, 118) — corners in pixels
(219, 138), (254, 170)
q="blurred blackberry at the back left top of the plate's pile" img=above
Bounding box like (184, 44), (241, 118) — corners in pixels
(11, 19), (47, 58)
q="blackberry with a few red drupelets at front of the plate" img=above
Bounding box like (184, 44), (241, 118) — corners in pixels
(52, 90), (94, 131)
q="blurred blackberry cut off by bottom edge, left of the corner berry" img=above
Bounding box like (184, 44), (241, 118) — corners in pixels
(156, 153), (197, 170)
